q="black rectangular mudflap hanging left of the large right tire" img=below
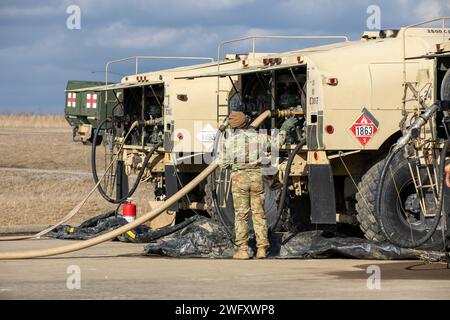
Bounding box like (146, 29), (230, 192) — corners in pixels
(308, 164), (336, 224)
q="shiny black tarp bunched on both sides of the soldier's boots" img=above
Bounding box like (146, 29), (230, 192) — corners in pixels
(144, 218), (442, 260)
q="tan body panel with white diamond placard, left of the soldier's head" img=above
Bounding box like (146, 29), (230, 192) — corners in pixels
(121, 53), (267, 154)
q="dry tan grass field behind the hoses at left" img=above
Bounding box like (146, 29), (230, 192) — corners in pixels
(0, 114), (152, 226)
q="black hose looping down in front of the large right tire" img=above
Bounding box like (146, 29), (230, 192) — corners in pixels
(375, 139), (450, 248)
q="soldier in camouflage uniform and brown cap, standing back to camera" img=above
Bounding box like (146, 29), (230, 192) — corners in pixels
(221, 112), (285, 259)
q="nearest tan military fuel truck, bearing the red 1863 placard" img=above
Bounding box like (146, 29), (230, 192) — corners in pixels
(176, 18), (450, 247)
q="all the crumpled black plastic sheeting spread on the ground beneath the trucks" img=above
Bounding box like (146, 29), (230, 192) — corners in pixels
(49, 211), (445, 261)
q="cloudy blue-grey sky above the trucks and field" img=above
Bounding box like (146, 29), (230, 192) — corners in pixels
(0, 0), (450, 113)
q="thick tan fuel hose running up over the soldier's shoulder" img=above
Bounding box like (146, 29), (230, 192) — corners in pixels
(0, 111), (271, 260)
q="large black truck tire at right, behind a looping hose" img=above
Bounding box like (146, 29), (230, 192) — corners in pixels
(356, 152), (450, 249)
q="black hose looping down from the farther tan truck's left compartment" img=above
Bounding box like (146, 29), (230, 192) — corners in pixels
(91, 118), (162, 204)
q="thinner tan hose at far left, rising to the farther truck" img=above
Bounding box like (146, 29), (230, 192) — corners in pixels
(0, 121), (139, 241)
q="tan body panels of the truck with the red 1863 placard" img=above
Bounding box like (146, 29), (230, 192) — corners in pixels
(244, 28), (450, 150)
